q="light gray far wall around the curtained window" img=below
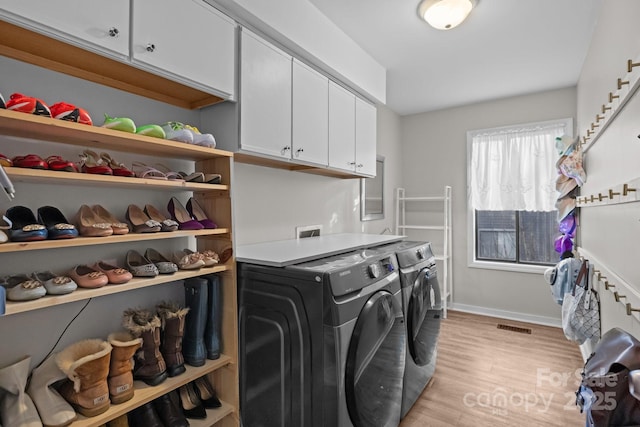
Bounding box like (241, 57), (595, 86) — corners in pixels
(401, 88), (576, 324)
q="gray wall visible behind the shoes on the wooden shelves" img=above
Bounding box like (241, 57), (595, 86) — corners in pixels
(0, 56), (198, 367)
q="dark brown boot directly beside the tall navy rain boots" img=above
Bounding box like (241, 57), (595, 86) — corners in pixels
(156, 301), (189, 377)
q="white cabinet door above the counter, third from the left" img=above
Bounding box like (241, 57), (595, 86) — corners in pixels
(329, 82), (356, 172)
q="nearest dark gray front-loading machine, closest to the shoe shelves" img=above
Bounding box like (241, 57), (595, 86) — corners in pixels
(238, 250), (407, 427)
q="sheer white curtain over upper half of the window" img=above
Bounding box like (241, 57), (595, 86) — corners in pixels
(469, 122), (566, 212)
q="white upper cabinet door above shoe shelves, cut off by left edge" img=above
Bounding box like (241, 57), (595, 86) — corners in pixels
(0, 0), (129, 59)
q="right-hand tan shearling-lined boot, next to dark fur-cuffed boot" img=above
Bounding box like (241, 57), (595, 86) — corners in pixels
(107, 332), (142, 404)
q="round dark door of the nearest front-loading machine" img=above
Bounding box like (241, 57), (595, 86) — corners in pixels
(345, 291), (406, 427)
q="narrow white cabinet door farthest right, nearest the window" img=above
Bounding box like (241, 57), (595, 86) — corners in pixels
(356, 98), (376, 176)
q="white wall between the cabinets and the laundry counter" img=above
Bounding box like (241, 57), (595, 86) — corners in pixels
(233, 102), (401, 244)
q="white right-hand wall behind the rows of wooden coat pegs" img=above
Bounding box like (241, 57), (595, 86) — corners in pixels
(578, 0), (640, 337)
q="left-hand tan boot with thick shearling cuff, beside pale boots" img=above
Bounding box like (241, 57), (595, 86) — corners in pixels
(56, 339), (111, 417)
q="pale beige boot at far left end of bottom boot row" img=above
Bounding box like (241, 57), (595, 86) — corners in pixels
(0, 356), (42, 427)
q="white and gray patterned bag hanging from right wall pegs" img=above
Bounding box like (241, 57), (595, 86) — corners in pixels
(562, 260), (600, 344)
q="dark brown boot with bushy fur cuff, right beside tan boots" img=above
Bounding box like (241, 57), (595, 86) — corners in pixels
(122, 309), (167, 386)
